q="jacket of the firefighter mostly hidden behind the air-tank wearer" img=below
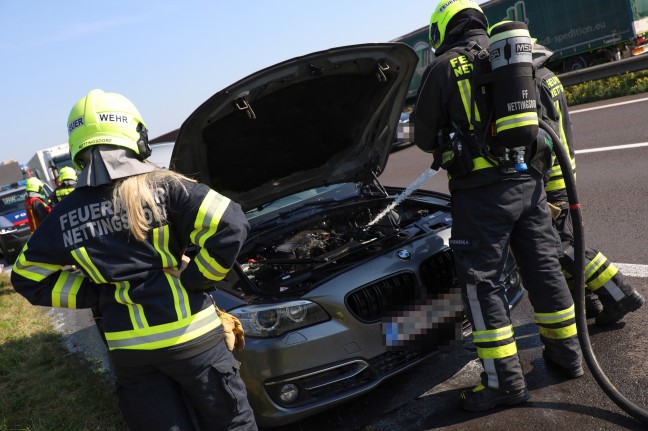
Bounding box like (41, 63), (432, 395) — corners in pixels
(535, 67), (576, 203)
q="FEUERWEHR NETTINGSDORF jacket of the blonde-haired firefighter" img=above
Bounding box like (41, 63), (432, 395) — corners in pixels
(11, 177), (249, 363)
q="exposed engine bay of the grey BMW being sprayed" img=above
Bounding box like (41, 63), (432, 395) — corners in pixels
(239, 200), (430, 293)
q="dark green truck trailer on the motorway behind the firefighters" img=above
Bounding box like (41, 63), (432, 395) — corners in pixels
(393, 0), (648, 103)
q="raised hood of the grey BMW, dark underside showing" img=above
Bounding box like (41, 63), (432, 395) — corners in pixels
(171, 43), (418, 211)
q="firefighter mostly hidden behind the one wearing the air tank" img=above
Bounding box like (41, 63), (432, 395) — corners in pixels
(534, 44), (645, 326)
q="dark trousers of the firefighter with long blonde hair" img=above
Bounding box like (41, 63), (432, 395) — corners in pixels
(113, 341), (257, 431)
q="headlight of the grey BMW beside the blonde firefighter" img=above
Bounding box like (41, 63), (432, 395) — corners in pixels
(229, 300), (329, 338)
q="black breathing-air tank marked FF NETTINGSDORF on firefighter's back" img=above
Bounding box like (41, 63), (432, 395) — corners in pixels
(459, 21), (538, 174)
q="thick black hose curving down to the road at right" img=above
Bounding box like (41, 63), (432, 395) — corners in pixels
(540, 120), (648, 425)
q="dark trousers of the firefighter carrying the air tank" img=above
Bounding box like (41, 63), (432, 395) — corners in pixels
(450, 176), (582, 390)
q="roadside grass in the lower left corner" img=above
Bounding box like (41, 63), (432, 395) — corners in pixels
(0, 273), (128, 431)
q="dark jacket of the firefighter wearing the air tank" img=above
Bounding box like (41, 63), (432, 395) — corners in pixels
(413, 29), (529, 192)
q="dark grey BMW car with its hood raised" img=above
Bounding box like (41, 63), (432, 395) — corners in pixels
(169, 43), (524, 427)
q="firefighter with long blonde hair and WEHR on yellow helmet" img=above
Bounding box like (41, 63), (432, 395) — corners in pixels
(11, 90), (257, 431)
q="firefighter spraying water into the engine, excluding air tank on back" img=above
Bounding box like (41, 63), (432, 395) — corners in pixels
(413, 0), (584, 411)
